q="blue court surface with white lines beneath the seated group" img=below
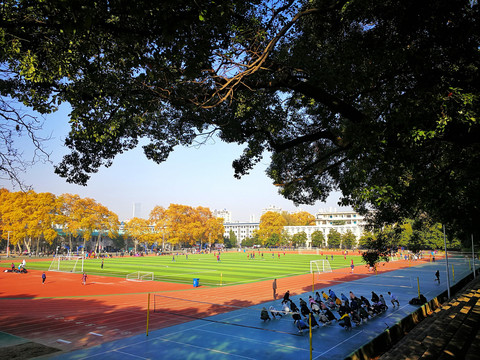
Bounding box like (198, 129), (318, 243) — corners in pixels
(48, 258), (471, 360)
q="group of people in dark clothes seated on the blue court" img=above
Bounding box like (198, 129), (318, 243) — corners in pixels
(260, 289), (388, 332)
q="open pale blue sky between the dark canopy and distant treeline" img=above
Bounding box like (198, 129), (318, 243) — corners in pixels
(0, 107), (348, 222)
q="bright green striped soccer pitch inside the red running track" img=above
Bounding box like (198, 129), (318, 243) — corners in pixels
(27, 251), (364, 286)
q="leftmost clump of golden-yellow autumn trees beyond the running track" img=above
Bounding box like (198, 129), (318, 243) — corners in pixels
(0, 189), (119, 252)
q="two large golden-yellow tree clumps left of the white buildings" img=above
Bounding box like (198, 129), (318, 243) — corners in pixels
(0, 189), (224, 253)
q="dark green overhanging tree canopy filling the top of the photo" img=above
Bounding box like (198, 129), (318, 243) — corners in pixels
(0, 0), (480, 239)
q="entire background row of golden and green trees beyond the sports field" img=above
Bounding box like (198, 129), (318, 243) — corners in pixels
(0, 189), (460, 256)
